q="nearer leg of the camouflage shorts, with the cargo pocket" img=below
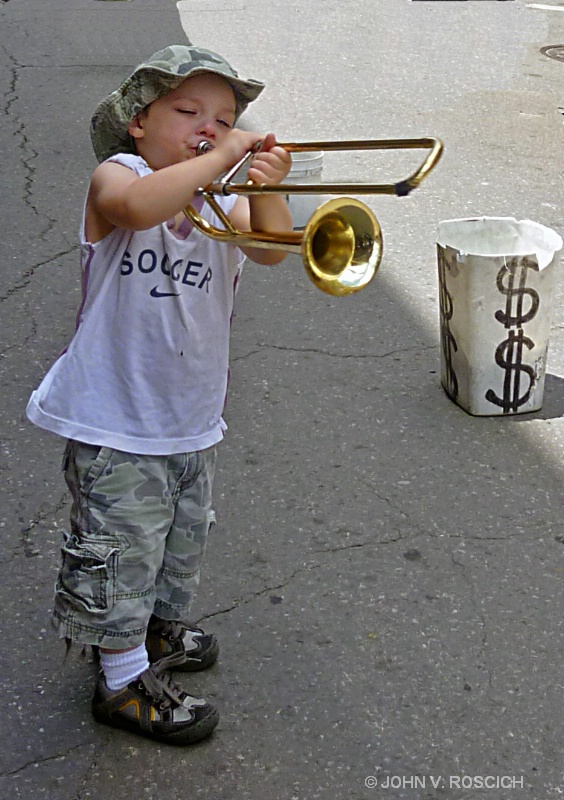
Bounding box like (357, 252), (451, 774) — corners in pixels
(53, 442), (174, 650)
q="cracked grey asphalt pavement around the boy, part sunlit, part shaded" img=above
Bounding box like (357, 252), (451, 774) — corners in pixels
(0, 0), (564, 800)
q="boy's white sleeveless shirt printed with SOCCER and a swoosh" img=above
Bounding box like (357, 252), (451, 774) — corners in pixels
(27, 155), (245, 455)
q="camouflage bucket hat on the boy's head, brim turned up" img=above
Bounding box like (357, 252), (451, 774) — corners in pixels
(90, 45), (264, 161)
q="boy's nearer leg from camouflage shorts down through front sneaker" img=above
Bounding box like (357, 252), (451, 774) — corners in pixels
(54, 442), (219, 745)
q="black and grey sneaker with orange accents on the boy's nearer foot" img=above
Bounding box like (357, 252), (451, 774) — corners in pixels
(92, 656), (219, 745)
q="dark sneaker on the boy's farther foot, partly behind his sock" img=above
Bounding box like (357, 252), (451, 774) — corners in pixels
(147, 616), (219, 672)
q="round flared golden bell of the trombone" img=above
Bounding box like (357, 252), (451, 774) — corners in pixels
(302, 197), (382, 297)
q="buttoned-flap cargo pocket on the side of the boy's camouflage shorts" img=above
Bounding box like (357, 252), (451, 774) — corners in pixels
(55, 531), (120, 614)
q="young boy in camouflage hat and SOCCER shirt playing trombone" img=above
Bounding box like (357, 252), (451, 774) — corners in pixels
(27, 45), (292, 745)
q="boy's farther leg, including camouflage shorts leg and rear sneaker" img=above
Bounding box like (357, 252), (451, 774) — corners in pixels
(147, 447), (219, 672)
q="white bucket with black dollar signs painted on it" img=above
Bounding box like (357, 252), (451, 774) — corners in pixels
(437, 217), (563, 415)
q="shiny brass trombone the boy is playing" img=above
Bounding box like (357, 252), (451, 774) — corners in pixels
(184, 138), (443, 296)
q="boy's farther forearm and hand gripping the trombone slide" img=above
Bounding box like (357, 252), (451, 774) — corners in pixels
(229, 134), (293, 264)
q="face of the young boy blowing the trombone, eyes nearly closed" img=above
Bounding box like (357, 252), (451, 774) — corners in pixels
(129, 73), (235, 169)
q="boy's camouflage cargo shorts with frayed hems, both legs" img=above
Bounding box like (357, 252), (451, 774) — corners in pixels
(53, 441), (216, 650)
